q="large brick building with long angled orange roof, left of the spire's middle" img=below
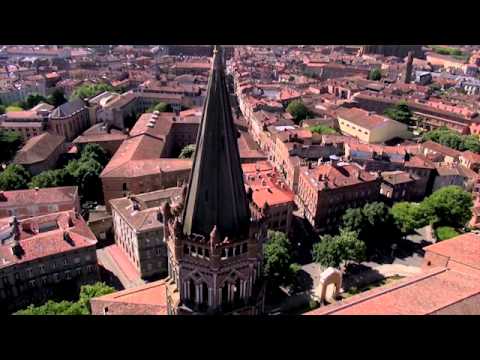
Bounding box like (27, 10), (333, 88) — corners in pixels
(100, 113), (198, 209)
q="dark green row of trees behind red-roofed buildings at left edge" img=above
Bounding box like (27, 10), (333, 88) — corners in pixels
(0, 144), (109, 200)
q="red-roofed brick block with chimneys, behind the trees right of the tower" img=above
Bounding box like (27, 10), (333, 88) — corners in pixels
(296, 162), (380, 230)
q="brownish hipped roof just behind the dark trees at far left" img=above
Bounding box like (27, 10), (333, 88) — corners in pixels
(13, 132), (65, 165)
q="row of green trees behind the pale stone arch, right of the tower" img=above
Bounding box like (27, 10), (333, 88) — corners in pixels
(312, 186), (473, 267)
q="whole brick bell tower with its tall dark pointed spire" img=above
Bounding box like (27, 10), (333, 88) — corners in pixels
(161, 47), (266, 315)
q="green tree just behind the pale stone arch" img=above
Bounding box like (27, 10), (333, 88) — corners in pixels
(312, 230), (366, 268)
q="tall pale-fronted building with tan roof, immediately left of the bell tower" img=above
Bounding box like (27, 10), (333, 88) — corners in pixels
(110, 188), (181, 278)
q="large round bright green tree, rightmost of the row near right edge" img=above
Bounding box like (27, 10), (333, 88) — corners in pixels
(422, 185), (473, 227)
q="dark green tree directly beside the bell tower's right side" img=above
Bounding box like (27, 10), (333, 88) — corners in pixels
(264, 230), (299, 285)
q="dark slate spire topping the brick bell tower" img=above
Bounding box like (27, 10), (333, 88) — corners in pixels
(183, 47), (250, 238)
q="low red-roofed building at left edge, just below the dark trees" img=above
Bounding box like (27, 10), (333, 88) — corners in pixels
(0, 186), (80, 220)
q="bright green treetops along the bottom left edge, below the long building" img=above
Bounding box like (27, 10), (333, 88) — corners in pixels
(15, 282), (115, 315)
